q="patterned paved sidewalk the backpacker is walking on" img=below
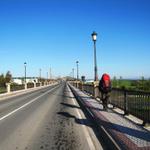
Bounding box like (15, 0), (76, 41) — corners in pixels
(70, 85), (150, 150)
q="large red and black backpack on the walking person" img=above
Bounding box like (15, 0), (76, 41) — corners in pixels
(99, 73), (111, 92)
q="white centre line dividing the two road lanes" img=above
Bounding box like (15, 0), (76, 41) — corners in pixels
(0, 85), (59, 121)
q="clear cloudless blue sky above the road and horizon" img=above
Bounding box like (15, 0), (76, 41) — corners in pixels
(0, 0), (150, 78)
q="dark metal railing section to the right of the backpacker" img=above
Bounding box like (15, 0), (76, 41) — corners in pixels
(110, 89), (150, 124)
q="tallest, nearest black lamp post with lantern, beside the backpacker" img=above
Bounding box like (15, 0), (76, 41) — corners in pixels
(91, 32), (98, 81)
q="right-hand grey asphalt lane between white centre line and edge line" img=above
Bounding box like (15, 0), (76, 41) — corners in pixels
(0, 83), (101, 150)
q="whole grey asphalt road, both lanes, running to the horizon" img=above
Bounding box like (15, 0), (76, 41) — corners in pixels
(0, 82), (101, 150)
